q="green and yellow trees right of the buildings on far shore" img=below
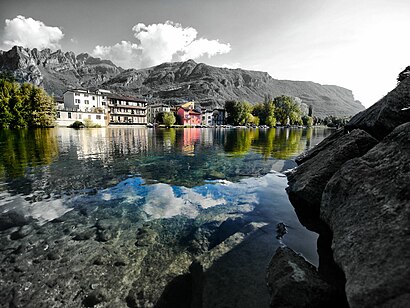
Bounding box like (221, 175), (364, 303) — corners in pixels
(225, 95), (313, 127)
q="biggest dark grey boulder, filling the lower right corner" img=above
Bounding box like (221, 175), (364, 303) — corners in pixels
(320, 123), (410, 307)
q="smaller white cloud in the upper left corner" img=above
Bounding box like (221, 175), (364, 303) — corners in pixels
(3, 15), (64, 50)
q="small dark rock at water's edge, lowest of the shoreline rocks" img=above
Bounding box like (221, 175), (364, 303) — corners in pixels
(267, 247), (346, 307)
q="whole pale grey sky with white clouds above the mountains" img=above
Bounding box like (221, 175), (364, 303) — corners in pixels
(0, 0), (410, 107)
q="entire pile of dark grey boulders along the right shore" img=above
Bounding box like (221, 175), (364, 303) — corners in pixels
(267, 67), (410, 307)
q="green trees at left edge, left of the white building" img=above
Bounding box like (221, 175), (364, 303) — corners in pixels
(0, 74), (56, 128)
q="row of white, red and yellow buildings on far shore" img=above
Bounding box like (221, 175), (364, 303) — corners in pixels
(55, 89), (226, 127)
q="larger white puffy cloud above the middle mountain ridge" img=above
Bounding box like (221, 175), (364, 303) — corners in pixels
(93, 21), (231, 68)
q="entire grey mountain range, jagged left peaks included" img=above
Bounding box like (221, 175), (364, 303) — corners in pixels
(0, 46), (364, 117)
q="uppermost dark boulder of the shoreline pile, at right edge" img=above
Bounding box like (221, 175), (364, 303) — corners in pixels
(345, 71), (410, 140)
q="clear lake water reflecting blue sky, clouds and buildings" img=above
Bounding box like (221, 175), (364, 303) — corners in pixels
(0, 127), (331, 307)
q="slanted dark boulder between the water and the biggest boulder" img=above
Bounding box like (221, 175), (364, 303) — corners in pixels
(286, 129), (377, 216)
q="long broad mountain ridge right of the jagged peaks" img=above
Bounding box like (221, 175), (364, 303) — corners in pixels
(104, 60), (364, 117)
